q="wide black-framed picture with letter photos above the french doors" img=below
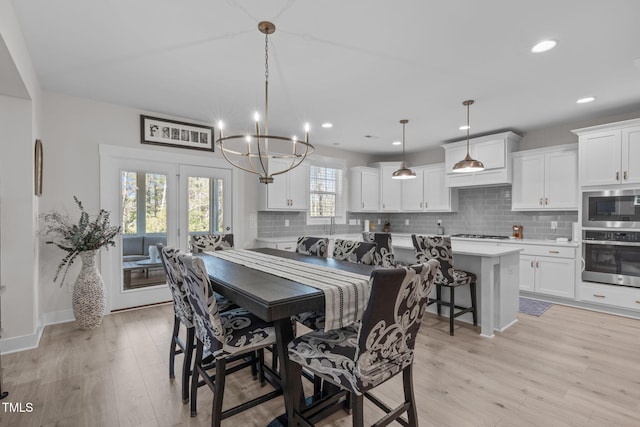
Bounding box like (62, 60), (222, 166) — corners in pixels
(140, 114), (215, 151)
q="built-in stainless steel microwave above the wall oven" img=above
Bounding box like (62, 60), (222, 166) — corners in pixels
(582, 189), (640, 228)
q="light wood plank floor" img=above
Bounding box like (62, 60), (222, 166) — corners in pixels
(0, 305), (640, 427)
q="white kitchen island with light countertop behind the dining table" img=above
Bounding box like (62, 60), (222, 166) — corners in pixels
(256, 234), (522, 337)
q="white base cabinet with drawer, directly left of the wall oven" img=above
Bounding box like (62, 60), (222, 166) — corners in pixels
(520, 245), (576, 298)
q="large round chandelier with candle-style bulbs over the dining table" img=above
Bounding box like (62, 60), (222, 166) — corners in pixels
(216, 21), (314, 184)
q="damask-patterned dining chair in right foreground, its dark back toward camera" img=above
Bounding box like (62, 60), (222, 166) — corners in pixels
(288, 260), (439, 427)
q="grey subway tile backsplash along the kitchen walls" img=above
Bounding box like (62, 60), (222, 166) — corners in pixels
(258, 186), (578, 239)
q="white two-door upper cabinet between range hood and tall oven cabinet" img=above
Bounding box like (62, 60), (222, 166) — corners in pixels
(511, 144), (578, 211)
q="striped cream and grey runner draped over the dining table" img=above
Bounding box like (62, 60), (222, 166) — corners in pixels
(205, 249), (370, 330)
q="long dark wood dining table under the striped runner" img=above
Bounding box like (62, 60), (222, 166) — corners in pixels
(197, 248), (380, 425)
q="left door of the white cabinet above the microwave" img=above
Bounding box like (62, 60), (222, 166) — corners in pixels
(580, 130), (622, 185)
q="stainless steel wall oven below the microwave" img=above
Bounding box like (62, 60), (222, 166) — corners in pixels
(582, 230), (640, 287)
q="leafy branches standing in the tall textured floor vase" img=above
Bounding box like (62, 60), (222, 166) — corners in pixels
(42, 196), (120, 286)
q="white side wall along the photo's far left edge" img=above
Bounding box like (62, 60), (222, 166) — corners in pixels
(0, 0), (42, 352)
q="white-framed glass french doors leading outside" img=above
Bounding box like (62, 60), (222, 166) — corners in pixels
(100, 147), (234, 311)
